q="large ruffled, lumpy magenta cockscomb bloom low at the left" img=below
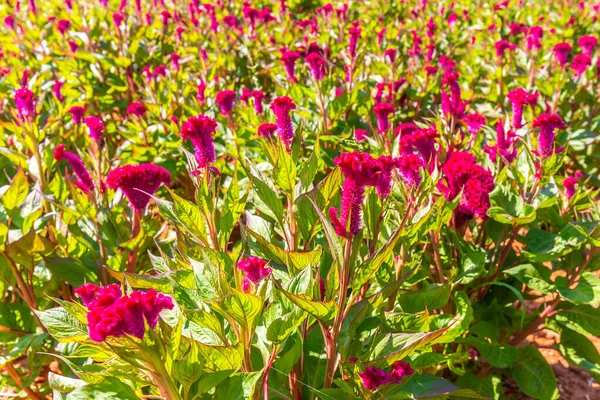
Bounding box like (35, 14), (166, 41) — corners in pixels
(75, 284), (174, 342)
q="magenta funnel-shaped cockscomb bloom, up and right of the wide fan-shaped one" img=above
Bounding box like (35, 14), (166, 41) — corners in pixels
(181, 115), (217, 168)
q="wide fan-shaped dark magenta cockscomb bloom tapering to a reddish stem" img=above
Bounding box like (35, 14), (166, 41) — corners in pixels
(106, 164), (171, 212)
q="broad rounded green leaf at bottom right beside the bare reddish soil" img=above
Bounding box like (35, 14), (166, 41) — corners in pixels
(512, 346), (558, 400)
